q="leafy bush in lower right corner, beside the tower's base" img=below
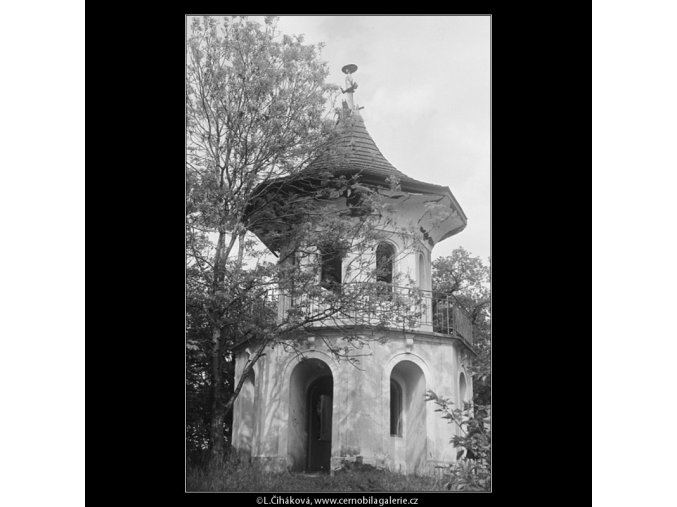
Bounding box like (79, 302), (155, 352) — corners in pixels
(427, 391), (491, 491)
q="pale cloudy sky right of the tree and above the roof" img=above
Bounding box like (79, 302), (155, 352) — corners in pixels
(187, 16), (491, 260)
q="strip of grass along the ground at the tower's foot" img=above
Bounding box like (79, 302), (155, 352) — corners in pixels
(186, 461), (448, 493)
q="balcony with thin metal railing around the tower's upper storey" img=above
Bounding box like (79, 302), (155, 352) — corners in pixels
(268, 283), (473, 345)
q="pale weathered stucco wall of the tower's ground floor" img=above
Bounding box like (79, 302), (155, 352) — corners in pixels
(233, 331), (472, 473)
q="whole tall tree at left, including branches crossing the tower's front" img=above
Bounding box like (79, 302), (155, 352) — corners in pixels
(186, 16), (422, 465)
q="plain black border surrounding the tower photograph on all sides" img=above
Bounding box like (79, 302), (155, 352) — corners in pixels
(86, 2), (591, 505)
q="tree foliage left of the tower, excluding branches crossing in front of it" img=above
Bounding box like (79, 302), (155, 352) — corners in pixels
(186, 16), (346, 463)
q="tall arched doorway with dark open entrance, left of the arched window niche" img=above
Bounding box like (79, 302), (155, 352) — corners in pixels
(287, 359), (334, 472)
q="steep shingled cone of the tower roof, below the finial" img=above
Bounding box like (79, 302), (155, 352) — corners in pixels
(302, 108), (423, 187)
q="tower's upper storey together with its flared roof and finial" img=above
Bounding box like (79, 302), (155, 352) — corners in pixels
(250, 65), (472, 346)
